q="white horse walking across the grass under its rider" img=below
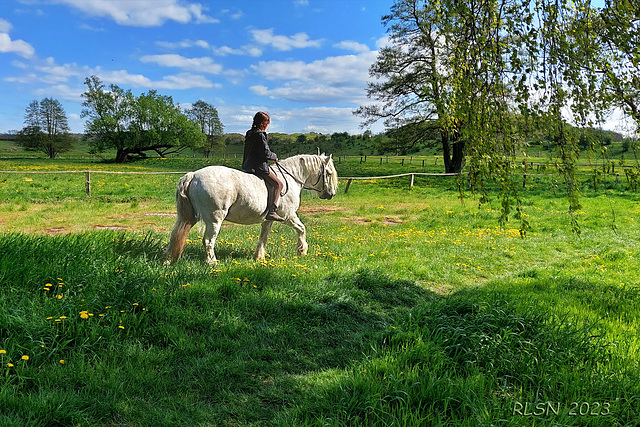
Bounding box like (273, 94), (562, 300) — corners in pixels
(164, 154), (338, 264)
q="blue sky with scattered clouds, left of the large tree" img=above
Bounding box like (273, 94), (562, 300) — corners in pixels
(0, 0), (393, 133)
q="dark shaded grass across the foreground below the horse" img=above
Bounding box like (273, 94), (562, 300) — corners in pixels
(0, 232), (640, 426)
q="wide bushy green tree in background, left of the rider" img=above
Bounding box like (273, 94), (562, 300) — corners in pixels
(82, 76), (206, 163)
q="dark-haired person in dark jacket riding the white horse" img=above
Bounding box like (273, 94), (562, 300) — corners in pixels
(242, 111), (284, 221)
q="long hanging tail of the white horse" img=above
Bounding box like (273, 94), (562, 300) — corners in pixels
(164, 172), (200, 264)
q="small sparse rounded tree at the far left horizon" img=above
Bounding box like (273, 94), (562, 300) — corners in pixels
(17, 98), (73, 159)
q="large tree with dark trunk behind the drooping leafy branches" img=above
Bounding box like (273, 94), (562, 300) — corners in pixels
(355, 0), (524, 173)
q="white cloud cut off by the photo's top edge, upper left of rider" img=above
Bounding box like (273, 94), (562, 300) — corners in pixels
(50, 0), (218, 27)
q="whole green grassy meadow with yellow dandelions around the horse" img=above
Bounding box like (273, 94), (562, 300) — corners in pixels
(0, 152), (640, 426)
